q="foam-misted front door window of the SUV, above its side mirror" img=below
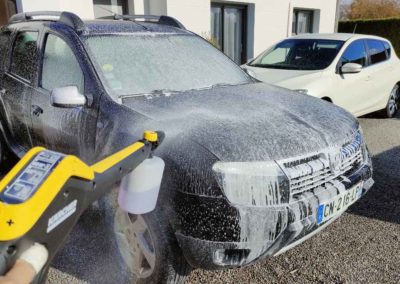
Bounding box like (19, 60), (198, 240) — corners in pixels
(41, 34), (84, 93)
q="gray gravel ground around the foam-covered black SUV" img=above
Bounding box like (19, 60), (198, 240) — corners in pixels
(42, 114), (400, 283)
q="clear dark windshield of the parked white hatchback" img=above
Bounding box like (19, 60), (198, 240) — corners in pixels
(250, 39), (344, 70)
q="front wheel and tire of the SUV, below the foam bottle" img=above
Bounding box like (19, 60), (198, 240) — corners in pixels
(114, 205), (191, 283)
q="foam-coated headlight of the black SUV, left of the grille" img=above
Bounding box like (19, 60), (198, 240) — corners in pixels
(213, 162), (290, 206)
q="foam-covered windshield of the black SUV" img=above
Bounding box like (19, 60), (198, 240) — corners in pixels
(87, 33), (251, 98)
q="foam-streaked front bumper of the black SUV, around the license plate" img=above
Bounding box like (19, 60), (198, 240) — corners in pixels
(176, 163), (373, 269)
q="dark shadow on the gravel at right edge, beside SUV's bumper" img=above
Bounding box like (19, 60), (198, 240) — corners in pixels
(347, 146), (400, 224)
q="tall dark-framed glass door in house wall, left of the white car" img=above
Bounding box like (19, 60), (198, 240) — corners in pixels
(211, 4), (246, 64)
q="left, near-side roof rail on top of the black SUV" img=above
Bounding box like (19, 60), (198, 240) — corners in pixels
(8, 11), (85, 33)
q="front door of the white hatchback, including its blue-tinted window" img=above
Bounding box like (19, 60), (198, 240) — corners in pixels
(329, 39), (371, 115)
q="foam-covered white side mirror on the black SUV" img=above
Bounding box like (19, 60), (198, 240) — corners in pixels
(50, 86), (86, 108)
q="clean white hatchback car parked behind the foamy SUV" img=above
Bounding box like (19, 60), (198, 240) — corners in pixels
(243, 34), (400, 117)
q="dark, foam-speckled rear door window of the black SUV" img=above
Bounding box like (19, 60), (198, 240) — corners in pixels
(10, 32), (38, 81)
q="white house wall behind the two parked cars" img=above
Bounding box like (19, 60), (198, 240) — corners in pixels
(18, 0), (337, 58)
